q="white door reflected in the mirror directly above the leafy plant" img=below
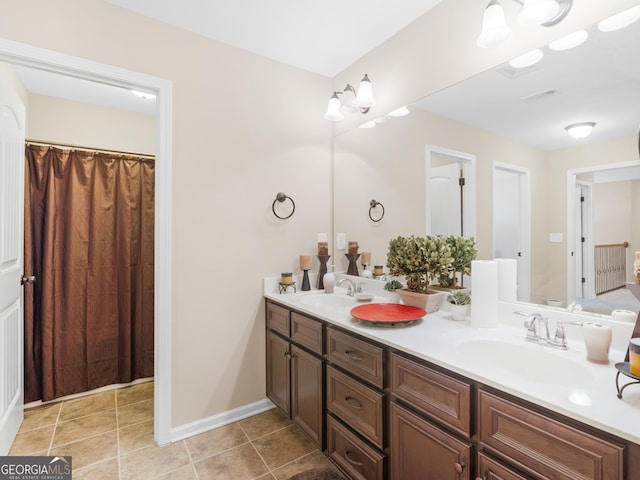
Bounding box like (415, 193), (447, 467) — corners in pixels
(429, 162), (462, 235)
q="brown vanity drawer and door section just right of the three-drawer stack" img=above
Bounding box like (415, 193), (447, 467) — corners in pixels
(389, 352), (473, 480)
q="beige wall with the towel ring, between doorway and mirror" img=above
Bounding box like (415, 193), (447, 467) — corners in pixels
(0, 0), (331, 427)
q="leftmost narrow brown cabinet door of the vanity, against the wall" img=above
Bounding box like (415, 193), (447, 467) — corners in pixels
(267, 331), (291, 416)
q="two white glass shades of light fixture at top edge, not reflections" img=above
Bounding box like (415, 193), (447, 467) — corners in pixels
(476, 0), (572, 48)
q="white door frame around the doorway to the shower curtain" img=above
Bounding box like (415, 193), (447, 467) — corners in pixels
(0, 39), (172, 445)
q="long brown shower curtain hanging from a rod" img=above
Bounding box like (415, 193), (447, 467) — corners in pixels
(24, 144), (154, 402)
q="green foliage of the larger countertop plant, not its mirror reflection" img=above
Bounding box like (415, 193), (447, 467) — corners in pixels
(387, 235), (453, 293)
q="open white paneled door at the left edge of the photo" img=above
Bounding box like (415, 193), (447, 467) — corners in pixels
(0, 75), (25, 455)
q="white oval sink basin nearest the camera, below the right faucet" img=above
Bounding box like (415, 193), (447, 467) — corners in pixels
(457, 338), (593, 387)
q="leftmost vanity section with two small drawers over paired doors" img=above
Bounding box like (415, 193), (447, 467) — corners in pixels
(266, 302), (325, 448)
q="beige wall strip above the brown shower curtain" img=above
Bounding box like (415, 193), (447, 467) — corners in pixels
(27, 94), (155, 154)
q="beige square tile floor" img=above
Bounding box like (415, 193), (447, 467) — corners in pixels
(10, 382), (344, 480)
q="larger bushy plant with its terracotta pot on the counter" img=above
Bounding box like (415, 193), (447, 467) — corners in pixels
(387, 235), (453, 312)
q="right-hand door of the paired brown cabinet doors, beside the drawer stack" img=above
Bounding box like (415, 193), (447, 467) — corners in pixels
(291, 345), (323, 447)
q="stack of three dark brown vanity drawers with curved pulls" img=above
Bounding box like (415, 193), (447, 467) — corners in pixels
(326, 327), (387, 480)
